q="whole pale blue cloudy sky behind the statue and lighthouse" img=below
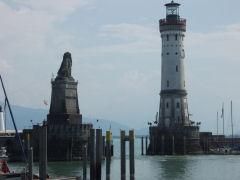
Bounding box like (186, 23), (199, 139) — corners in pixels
(0, 0), (240, 134)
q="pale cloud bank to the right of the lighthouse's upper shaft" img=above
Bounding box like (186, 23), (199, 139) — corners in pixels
(185, 24), (240, 60)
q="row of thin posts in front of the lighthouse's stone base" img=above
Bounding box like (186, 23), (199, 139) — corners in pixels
(141, 135), (186, 155)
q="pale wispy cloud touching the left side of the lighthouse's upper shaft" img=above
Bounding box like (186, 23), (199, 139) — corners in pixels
(79, 23), (161, 57)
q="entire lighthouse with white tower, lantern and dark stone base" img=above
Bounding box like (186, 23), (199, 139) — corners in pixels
(147, 1), (202, 155)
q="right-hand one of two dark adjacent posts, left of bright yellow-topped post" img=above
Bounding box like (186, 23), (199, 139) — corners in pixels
(96, 129), (103, 180)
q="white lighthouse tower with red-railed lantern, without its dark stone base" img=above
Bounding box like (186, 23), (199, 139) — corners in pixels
(159, 1), (190, 128)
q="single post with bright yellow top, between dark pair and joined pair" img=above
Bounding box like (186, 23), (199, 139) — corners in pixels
(106, 131), (111, 180)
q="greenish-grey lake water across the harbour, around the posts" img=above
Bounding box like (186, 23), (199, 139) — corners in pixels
(9, 138), (240, 180)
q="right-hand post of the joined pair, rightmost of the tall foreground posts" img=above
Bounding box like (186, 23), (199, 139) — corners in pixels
(129, 130), (135, 180)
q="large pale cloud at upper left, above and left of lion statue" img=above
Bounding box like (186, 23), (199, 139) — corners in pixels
(0, 0), (90, 108)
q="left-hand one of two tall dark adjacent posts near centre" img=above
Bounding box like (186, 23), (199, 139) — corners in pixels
(89, 129), (96, 180)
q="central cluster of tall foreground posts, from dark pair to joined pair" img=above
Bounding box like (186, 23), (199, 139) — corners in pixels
(90, 129), (135, 180)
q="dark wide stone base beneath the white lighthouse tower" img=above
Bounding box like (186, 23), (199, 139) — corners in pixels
(147, 126), (203, 155)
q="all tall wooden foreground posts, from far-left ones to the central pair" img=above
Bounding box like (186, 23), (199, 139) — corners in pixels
(27, 125), (135, 180)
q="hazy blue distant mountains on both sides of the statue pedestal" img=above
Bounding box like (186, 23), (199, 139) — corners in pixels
(0, 102), (148, 136)
